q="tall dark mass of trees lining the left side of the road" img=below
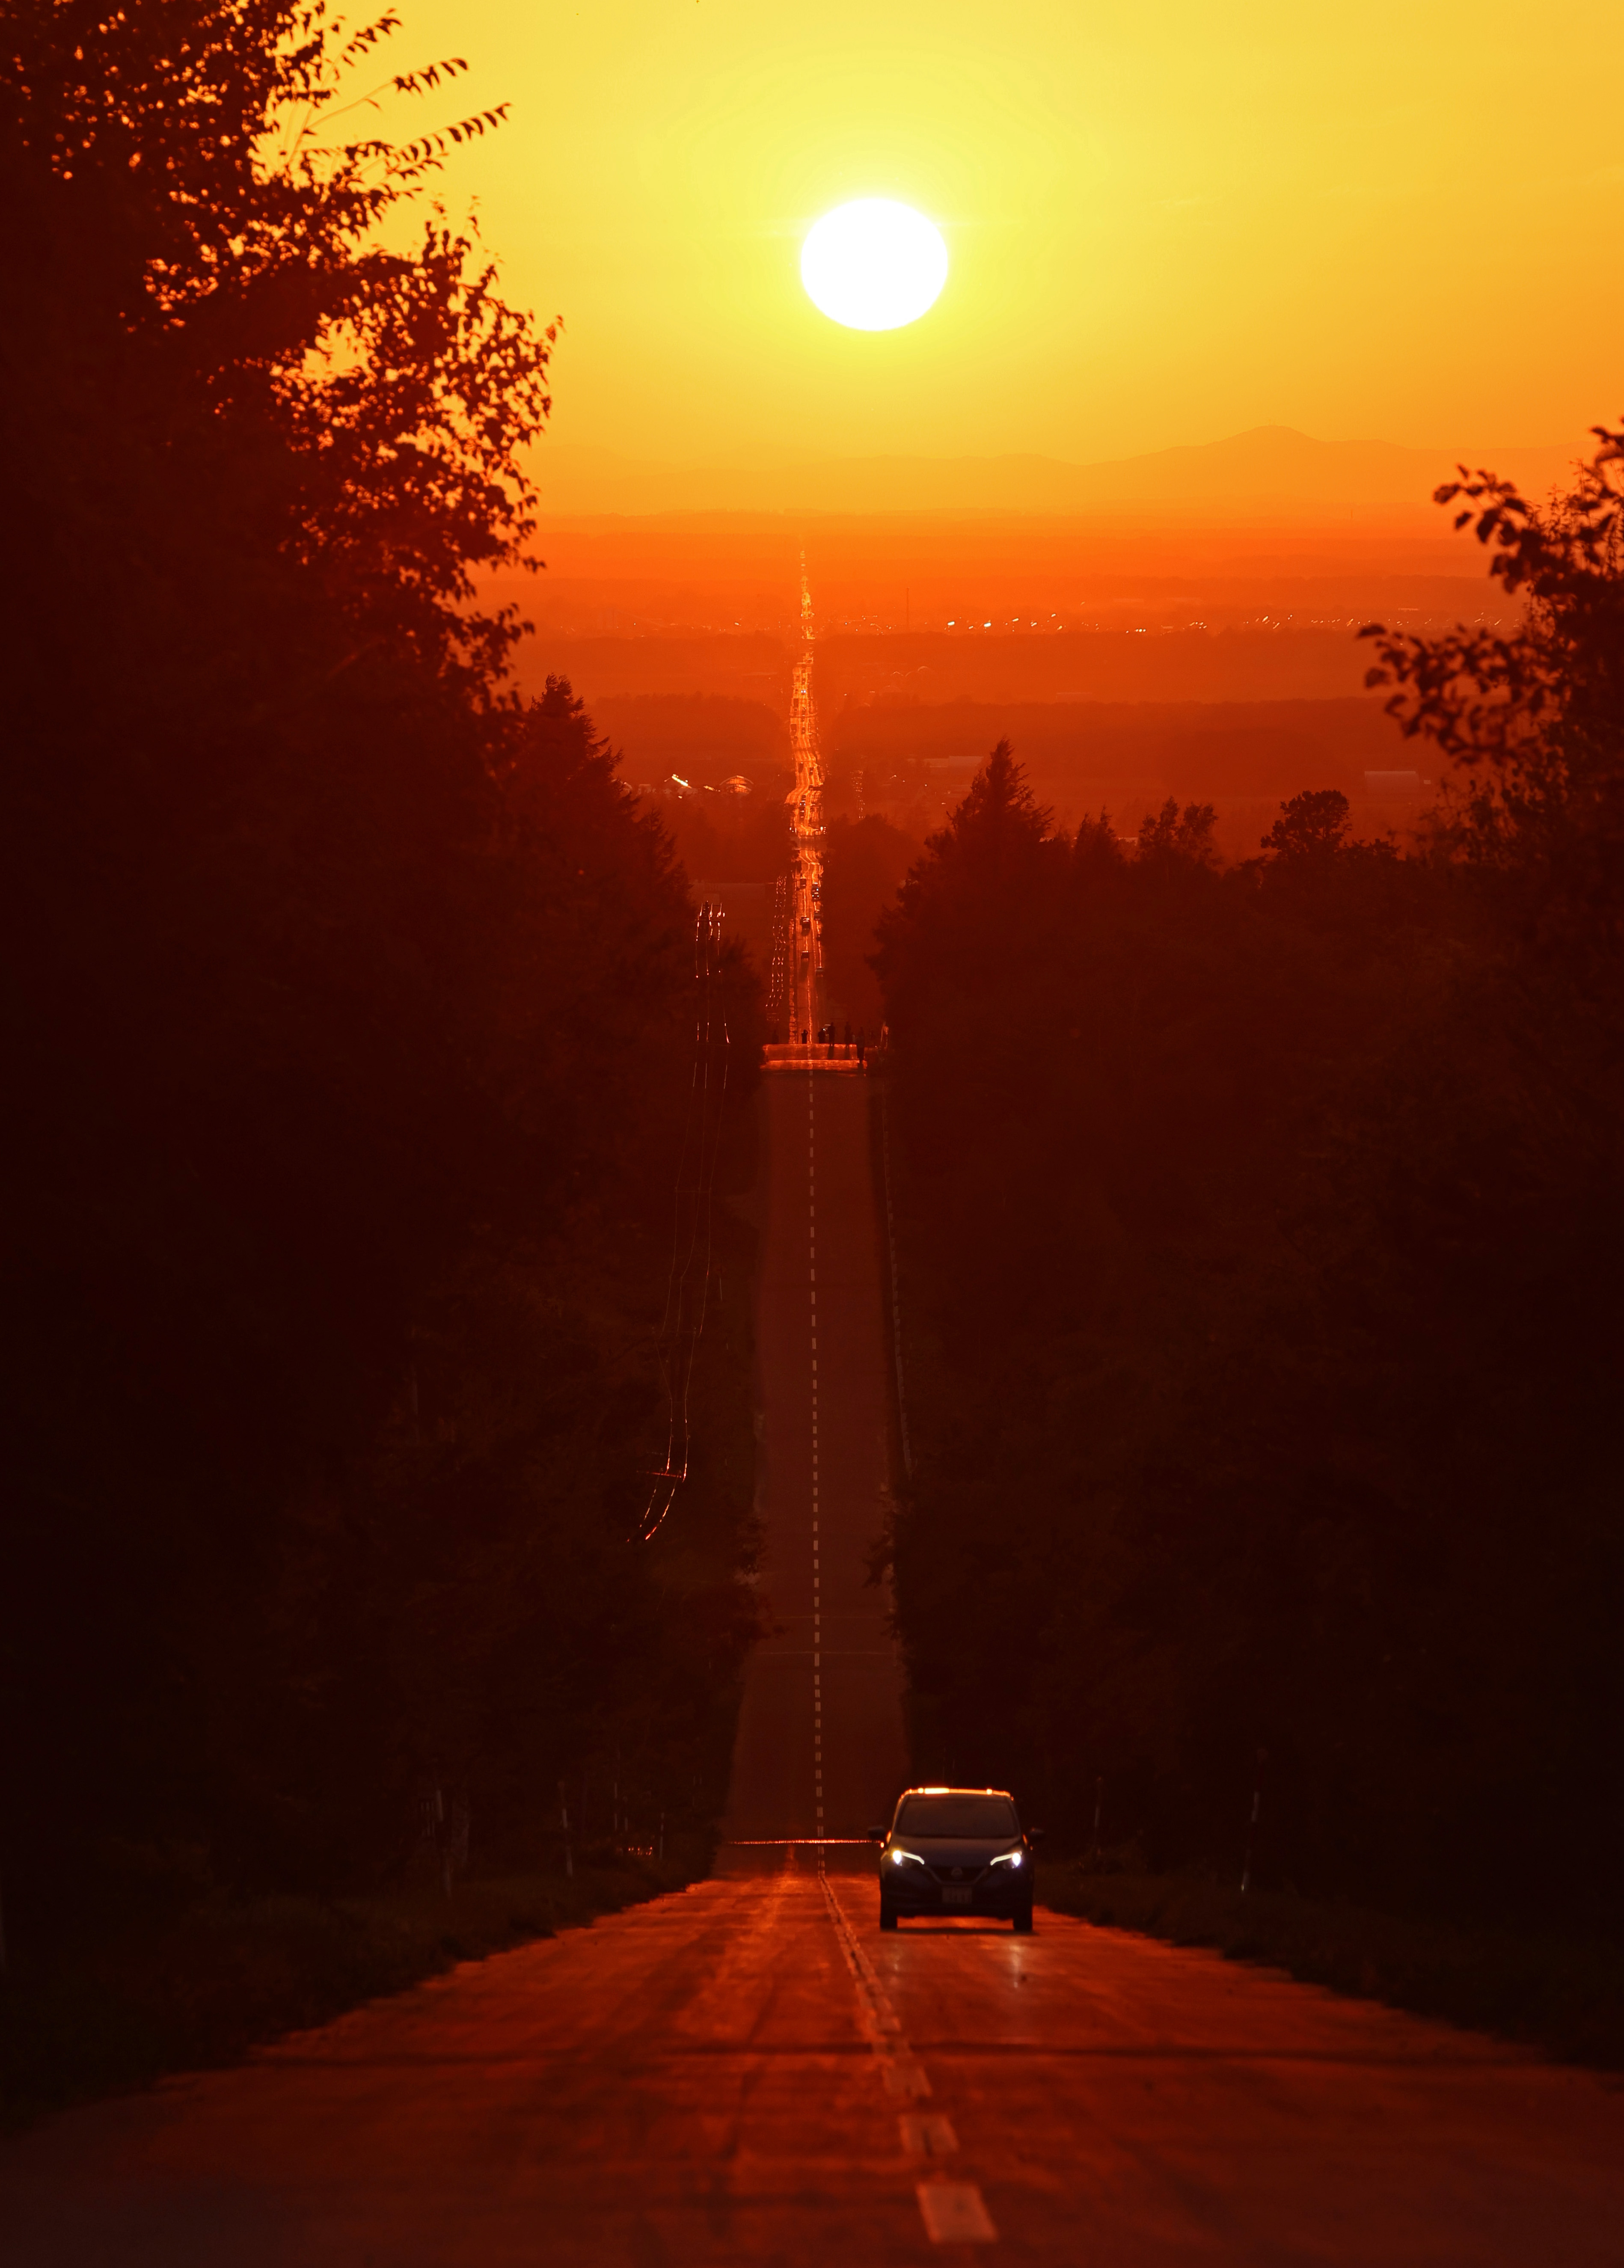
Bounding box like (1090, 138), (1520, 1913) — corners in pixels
(0, 0), (760, 1964)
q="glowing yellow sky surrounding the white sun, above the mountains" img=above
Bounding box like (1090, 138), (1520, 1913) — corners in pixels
(386, 0), (1624, 463)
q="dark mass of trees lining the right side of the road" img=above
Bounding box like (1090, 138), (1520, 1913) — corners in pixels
(878, 436), (1624, 1930)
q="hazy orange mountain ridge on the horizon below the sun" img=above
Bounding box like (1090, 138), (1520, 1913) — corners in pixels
(535, 426), (1583, 517)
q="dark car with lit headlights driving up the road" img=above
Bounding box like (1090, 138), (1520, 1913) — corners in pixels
(869, 1787), (1043, 1937)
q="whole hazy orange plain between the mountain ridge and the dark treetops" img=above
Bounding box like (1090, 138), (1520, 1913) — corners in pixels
(492, 504), (1506, 852)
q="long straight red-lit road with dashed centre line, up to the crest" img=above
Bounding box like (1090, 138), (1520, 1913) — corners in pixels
(0, 1073), (1624, 2268)
